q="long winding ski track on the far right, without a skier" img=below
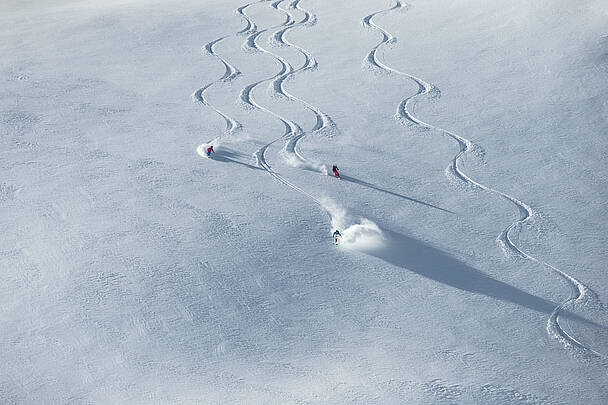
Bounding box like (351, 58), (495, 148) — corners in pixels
(361, 0), (606, 358)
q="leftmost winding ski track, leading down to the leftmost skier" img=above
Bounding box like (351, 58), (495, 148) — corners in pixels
(192, 0), (266, 156)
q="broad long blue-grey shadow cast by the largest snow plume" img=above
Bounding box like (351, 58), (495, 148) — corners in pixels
(358, 230), (605, 329)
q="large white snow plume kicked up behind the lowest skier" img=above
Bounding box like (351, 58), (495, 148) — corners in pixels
(321, 198), (385, 249)
